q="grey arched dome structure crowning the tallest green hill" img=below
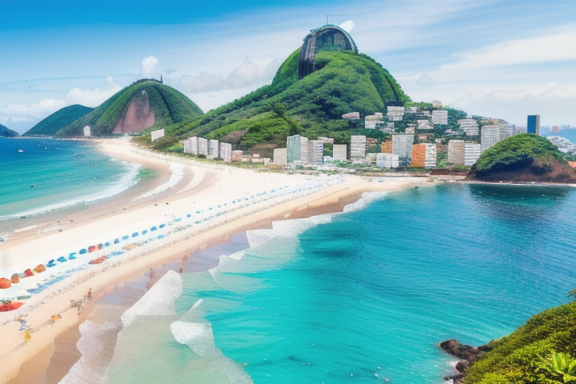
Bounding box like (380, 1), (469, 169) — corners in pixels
(298, 24), (358, 79)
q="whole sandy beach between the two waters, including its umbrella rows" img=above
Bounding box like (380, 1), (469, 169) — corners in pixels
(0, 139), (432, 383)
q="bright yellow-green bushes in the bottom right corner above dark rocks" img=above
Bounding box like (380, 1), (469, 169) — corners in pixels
(464, 302), (576, 384)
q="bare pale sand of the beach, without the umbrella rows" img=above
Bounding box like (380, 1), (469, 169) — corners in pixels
(0, 139), (431, 383)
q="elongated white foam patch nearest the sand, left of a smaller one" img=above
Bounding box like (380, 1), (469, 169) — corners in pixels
(121, 270), (183, 327)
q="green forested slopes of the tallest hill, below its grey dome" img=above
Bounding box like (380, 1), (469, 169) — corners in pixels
(140, 49), (410, 155)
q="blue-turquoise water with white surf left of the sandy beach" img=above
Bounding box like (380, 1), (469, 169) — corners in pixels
(0, 138), (137, 222)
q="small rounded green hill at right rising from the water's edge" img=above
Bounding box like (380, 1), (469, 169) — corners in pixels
(468, 134), (576, 183)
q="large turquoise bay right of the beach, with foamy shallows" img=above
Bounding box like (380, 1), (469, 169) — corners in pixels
(62, 185), (576, 384)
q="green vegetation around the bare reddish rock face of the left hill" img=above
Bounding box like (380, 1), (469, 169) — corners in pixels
(57, 80), (202, 137)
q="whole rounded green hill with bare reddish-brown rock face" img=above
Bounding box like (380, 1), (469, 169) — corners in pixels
(57, 79), (202, 137)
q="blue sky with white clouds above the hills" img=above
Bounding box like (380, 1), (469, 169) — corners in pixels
(0, 0), (576, 133)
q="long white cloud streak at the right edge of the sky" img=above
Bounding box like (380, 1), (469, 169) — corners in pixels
(441, 26), (576, 70)
